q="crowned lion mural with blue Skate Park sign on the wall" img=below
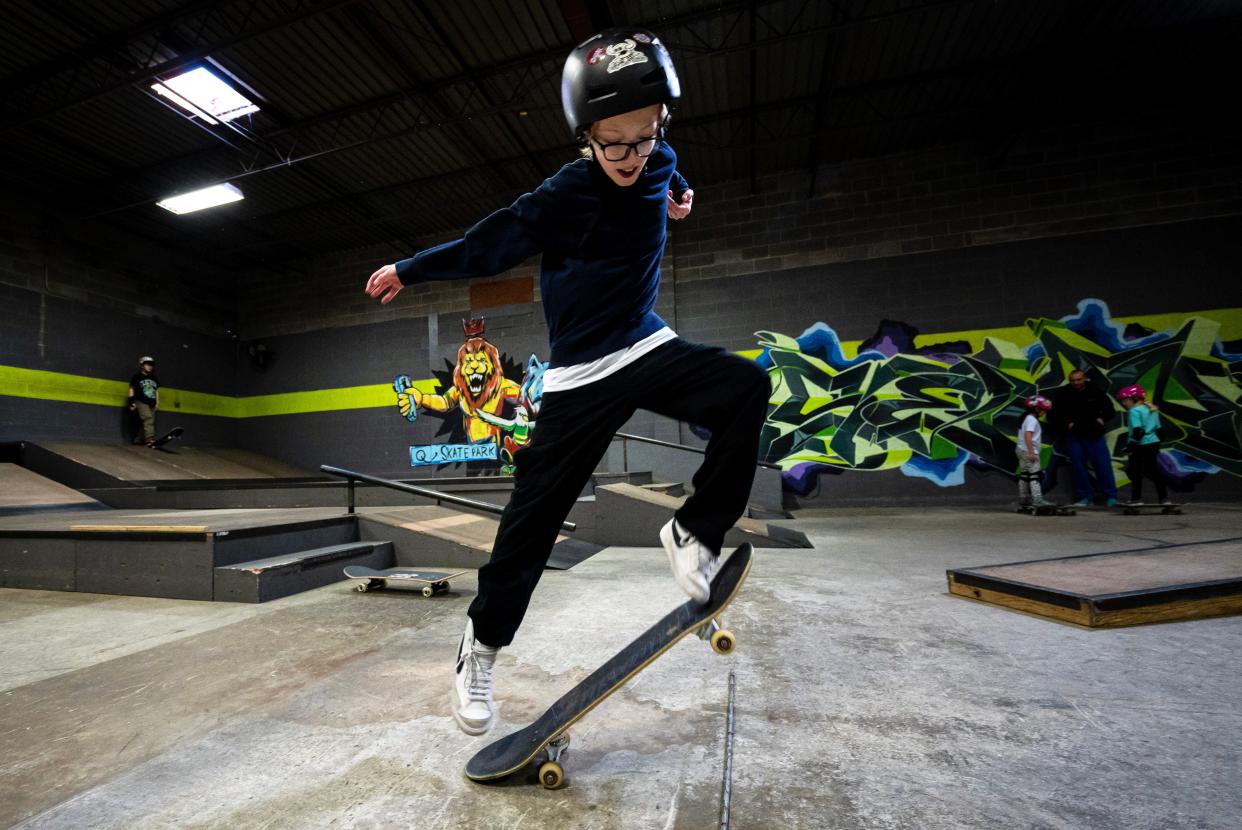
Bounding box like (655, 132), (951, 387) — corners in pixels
(392, 319), (548, 475)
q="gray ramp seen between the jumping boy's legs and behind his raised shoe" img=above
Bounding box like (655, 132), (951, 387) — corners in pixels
(591, 485), (814, 548)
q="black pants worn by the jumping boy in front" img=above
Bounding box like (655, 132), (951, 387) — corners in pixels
(469, 339), (771, 646)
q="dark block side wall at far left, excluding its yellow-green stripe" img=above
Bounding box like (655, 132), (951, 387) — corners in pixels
(0, 199), (236, 445)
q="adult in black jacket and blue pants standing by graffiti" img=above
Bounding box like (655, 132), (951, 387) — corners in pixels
(1052, 369), (1117, 507)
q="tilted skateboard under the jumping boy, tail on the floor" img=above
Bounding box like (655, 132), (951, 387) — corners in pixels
(466, 543), (753, 789)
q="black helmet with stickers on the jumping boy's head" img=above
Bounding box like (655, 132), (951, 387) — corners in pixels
(560, 29), (682, 139)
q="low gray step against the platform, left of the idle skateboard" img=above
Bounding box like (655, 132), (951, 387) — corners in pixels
(214, 542), (394, 603)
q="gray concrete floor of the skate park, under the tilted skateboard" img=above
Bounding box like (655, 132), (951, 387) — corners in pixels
(0, 504), (1242, 830)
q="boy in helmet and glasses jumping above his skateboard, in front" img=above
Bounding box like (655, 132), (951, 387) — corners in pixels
(366, 29), (771, 734)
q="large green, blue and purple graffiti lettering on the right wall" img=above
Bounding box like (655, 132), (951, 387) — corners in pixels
(756, 299), (1242, 495)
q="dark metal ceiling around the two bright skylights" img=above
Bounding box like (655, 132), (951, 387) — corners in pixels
(0, 0), (1242, 268)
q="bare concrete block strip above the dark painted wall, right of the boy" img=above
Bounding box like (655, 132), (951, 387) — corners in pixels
(673, 113), (1242, 291)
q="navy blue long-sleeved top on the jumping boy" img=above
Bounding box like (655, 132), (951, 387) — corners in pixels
(396, 142), (689, 367)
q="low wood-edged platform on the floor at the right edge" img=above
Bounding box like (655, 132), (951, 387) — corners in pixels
(948, 538), (1242, 627)
